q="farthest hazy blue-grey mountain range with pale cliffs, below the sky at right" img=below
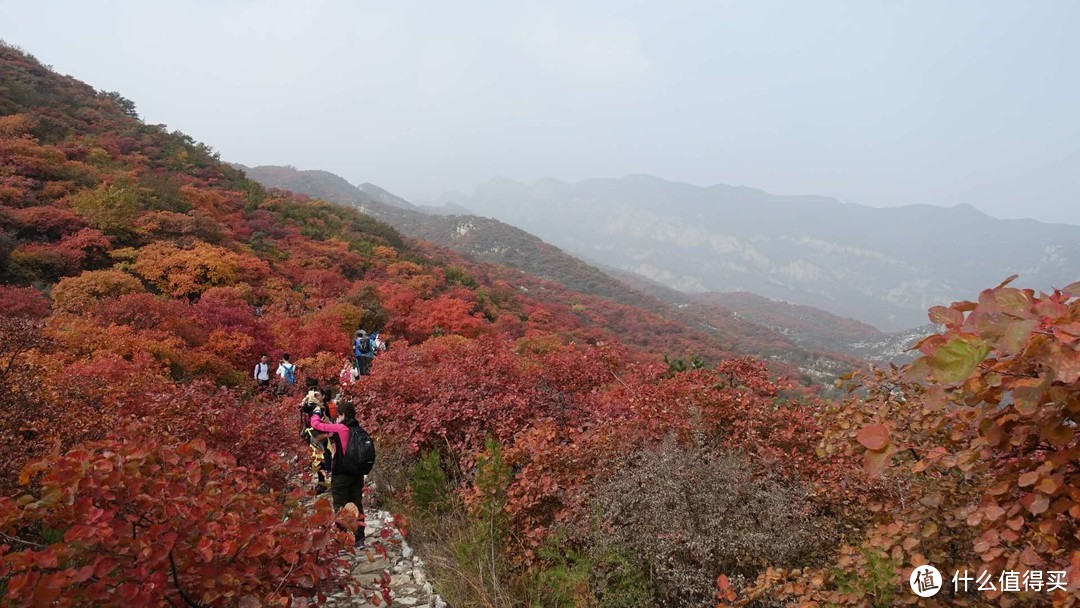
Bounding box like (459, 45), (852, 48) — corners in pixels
(438, 175), (1080, 330)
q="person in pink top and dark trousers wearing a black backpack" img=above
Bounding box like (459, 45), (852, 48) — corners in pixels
(311, 402), (375, 548)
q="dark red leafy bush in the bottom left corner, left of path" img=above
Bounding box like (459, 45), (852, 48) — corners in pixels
(0, 440), (343, 606)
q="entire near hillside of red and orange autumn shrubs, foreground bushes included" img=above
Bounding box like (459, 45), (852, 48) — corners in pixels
(0, 45), (1080, 607)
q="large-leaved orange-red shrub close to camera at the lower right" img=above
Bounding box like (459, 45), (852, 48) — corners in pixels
(738, 281), (1080, 606)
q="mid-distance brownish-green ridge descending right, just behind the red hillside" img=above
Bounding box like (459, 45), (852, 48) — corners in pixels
(239, 166), (911, 381)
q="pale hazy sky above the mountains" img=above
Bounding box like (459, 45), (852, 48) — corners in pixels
(6, 0), (1080, 224)
